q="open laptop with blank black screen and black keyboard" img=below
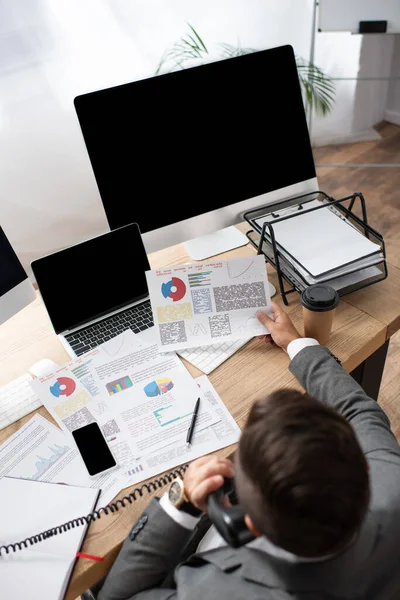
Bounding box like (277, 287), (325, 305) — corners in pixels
(31, 223), (154, 358)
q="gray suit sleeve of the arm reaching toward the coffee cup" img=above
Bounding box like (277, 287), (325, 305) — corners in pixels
(289, 346), (400, 464)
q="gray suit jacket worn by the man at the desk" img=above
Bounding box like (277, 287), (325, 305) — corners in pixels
(92, 346), (400, 600)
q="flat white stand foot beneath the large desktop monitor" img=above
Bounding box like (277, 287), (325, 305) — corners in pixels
(183, 225), (249, 260)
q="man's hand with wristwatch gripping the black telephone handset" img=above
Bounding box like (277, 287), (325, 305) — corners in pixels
(183, 456), (234, 512)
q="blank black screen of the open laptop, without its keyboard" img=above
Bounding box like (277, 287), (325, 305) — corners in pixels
(31, 223), (150, 333)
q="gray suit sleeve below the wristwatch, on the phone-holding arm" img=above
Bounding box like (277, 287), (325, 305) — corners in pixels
(97, 498), (191, 600)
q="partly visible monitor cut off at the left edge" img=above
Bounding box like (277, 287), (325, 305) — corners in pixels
(0, 227), (36, 324)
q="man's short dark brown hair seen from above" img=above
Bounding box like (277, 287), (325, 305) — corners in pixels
(237, 389), (369, 557)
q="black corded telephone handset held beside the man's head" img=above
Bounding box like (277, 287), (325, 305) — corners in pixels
(207, 479), (255, 548)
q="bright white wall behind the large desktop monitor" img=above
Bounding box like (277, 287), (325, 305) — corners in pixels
(0, 0), (396, 272)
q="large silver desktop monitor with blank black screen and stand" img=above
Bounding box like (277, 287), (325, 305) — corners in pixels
(74, 45), (318, 260)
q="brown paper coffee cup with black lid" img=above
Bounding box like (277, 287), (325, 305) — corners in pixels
(301, 283), (339, 346)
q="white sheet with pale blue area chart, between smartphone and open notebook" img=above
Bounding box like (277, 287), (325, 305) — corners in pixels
(0, 414), (128, 505)
